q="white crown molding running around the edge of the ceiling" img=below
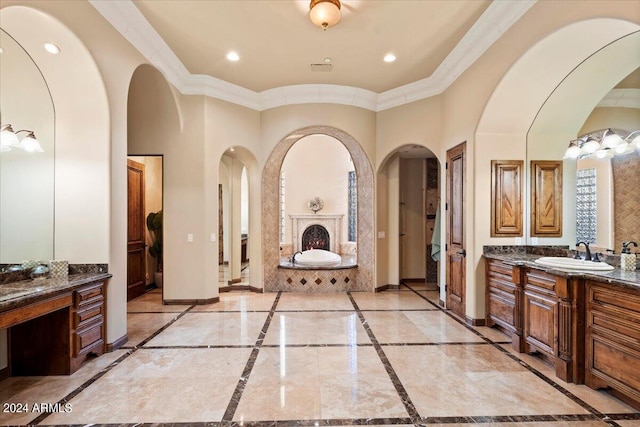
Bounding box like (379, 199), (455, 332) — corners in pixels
(89, 0), (537, 111)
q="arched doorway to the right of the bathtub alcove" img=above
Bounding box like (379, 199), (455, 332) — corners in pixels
(376, 144), (443, 289)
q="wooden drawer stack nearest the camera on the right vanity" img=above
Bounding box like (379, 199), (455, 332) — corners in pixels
(585, 281), (640, 407)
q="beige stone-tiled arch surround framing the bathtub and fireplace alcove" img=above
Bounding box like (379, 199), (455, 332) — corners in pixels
(262, 126), (375, 291)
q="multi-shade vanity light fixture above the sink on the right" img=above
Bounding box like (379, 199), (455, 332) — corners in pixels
(563, 128), (640, 159)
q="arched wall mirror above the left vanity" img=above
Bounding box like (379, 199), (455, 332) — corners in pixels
(0, 30), (55, 265)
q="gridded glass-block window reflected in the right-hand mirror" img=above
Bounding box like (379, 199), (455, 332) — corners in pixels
(576, 169), (596, 244)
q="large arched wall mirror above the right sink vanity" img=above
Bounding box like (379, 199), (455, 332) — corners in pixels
(525, 33), (640, 253)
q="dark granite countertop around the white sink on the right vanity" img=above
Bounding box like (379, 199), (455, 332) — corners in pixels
(484, 251), (640, 290)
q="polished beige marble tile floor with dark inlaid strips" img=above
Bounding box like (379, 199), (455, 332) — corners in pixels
(0, 285), (640, 427)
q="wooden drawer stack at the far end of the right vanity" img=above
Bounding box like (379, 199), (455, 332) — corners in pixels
(485, 259), (523, 351)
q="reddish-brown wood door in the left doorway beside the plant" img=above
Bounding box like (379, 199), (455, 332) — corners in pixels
(127, 160), (147, 301)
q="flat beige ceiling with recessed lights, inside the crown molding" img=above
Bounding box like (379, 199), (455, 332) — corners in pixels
(134, 0), (491, 93)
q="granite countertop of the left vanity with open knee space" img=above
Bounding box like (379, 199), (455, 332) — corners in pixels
(0, 273), (112, 313)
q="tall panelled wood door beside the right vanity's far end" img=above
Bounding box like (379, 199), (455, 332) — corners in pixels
(446, 143), (466, 319)
